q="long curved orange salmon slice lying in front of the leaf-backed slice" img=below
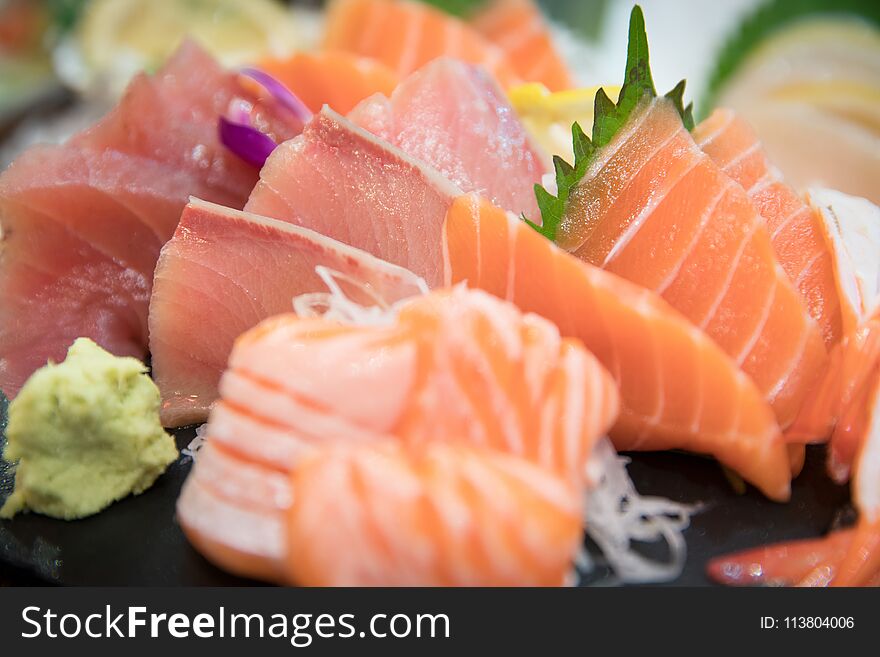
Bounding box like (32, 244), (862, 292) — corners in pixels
(444, 195), (790, 500)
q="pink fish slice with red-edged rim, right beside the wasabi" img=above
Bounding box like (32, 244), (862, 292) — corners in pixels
(150, 199), (424, 426)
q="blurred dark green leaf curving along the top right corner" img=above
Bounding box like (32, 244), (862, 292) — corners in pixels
(700, 0), (880, 117)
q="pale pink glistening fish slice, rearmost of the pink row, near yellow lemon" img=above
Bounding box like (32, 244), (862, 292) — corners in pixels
(349, 58), (546, 216)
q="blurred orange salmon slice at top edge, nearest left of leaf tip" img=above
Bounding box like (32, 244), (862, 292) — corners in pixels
(471, 0), (574, 91)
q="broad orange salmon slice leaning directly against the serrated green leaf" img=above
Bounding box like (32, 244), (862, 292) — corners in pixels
(557, 98), (827, 428)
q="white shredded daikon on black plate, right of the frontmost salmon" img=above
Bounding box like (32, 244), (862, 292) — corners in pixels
(577, 438), (700, 583)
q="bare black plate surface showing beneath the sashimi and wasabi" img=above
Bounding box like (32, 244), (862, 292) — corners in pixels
(0, 416), (849, 586)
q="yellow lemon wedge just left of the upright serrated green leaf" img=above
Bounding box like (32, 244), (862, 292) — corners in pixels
(508, 83), (620, 162)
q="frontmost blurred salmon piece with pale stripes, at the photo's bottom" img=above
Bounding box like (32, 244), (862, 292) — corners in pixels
(287, 443), (582, 586)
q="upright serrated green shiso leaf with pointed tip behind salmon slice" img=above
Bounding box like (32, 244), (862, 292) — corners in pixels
(525, 5), (694, 240)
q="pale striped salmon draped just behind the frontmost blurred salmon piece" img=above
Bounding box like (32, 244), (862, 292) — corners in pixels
(215, 287), (618, 483)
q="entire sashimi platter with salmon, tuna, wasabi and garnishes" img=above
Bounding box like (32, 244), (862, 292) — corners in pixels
(0, 0), (880, 586)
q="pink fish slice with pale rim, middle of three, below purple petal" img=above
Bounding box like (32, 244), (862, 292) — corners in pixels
(245, 107), (461, 287)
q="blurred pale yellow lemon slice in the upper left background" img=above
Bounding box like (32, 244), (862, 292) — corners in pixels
(56, 0), (306, 95)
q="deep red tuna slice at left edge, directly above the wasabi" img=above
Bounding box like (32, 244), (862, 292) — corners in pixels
(0, 199), (150, 397)
